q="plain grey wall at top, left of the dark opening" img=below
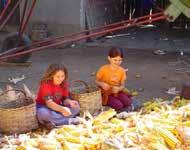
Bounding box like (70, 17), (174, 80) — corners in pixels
(22, 0), (80, 35)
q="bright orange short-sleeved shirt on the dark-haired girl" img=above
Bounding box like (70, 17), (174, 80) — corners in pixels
(96, 65), (127, 86)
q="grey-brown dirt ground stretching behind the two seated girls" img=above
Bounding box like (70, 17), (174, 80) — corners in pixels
(0, 27), (190, 105)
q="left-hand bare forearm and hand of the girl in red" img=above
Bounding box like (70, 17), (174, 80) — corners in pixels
(46, 100), (71, 116)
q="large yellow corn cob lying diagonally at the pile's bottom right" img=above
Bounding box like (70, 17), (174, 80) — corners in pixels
(156, 127), (181, 149)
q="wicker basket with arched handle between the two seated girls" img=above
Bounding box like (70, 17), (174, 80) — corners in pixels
(71, 80), (102, 115)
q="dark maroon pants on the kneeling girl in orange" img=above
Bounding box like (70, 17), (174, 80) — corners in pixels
(107, 92), (132, 111)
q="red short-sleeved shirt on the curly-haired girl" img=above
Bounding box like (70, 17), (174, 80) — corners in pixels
(36, 81), (69, 105)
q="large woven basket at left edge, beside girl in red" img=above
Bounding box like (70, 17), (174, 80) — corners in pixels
(0, 90), (38, 134)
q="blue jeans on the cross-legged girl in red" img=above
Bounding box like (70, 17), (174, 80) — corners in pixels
(37, 105), (80, 126)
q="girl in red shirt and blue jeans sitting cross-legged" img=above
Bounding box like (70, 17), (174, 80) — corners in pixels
(36, 64), (80, 127)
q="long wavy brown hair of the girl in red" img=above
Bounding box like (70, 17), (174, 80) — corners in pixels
(41, 64), (68, 86)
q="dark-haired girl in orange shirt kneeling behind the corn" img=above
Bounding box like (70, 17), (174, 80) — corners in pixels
(95, 48), (132, 111)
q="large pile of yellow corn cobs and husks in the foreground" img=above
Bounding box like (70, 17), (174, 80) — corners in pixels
(1, 98), (190, 150)
